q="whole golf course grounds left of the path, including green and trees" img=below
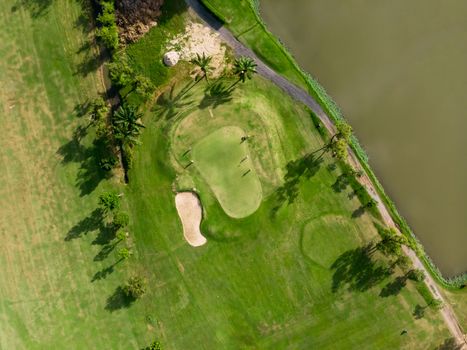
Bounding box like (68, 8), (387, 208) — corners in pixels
(0, 0), (467, 350)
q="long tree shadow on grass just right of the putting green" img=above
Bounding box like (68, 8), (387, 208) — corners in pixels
(272, 153), (323, 215)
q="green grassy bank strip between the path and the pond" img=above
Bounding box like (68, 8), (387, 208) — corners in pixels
(201, 0), (467, 291)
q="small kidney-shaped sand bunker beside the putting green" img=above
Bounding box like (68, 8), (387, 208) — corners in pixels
(175, 192), (206, 247)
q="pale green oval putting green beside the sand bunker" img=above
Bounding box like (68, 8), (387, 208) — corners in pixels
(193, 126), (262, 218)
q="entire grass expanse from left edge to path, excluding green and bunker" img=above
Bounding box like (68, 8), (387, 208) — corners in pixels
(0, 0), (454, 349)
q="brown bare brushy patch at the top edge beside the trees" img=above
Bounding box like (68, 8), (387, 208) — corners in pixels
(115, 0), (164, 44)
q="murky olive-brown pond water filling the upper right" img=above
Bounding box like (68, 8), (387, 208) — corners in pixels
(260, 0), (467, 277)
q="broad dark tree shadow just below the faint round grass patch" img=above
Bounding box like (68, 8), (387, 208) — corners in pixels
(331, 244), (392, 293)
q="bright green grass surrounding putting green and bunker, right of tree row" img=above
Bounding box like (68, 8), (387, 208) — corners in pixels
(122, 67), (448, 349)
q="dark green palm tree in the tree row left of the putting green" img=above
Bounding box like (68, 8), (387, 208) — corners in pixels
(112, 104), (144, 147)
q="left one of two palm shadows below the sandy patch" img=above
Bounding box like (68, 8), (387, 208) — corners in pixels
(155, 83), (194, 120)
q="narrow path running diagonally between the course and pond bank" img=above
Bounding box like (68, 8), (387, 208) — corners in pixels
(185, 0), (467, 344)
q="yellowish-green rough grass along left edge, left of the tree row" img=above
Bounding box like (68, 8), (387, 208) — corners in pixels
(0, 0), (148, 350)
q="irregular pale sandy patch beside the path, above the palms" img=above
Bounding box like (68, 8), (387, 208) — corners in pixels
(167, 23), (225, 77)
